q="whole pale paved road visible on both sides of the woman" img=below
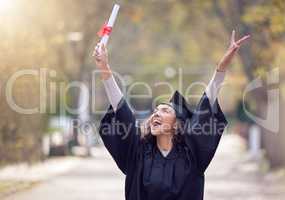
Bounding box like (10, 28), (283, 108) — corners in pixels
(3, 136), (285, 200)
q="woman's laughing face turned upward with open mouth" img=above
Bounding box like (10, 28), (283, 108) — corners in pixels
(149, 104), (176, 136)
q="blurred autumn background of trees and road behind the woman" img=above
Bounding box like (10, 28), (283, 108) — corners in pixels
(0, 0), (285, 199)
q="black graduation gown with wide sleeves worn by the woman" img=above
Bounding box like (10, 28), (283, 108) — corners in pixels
(99, 93), (227, 200)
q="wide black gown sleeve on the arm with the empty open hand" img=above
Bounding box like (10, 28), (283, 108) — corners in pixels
(185, 71), (228, 173)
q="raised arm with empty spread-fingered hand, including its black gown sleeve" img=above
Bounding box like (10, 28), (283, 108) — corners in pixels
(186, 31), (249, 173)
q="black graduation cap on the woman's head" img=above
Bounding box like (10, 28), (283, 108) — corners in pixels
(160, 90), (193, 121)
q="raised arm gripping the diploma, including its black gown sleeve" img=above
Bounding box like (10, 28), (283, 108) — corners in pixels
(93, 44), (140, 174)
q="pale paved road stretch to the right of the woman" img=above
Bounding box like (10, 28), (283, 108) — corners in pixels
(205, 135), (285, 200)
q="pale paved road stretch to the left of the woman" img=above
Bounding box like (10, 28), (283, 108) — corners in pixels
(5, 148), (124, 200)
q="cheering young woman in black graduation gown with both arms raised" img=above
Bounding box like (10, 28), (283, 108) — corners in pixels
(94, 31), (249, 200)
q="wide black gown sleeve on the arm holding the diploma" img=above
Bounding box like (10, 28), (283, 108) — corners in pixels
(99, 97), (140, 174)
